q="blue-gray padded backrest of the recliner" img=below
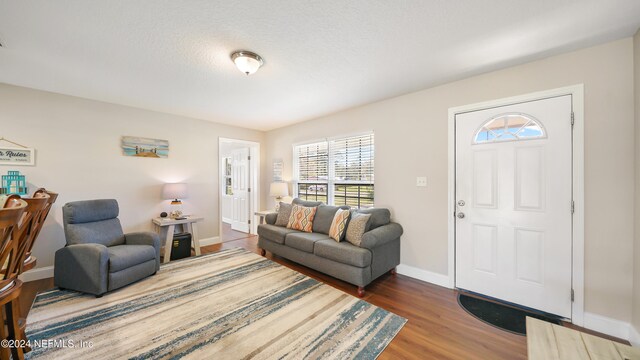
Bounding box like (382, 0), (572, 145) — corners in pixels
(62, 199), (124, 246)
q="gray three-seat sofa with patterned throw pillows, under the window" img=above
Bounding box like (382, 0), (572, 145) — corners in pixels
(258, 199), (402, 297)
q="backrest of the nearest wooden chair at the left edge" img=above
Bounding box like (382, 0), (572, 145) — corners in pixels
(0, 197), (28, 292)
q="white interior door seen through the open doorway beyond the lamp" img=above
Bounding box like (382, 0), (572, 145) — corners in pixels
(231, 148), (250, 233)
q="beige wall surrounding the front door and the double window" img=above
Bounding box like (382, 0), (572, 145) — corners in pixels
(263, 38), (634, 321)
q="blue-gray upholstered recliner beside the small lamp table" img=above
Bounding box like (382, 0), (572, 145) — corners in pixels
(54, 200), (160, 297)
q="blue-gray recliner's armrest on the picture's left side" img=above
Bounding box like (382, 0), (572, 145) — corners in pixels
(54, 244), (109, 295)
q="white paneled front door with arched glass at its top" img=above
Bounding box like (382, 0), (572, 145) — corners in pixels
(455, 95), (572, 318)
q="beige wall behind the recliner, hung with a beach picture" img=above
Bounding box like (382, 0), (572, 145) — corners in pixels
(0, 84), (264, 267)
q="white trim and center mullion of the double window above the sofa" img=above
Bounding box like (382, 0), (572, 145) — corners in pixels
(291, 130), (376, 205)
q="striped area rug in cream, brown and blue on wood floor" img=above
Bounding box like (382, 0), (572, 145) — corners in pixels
(27, 248), (407, 359)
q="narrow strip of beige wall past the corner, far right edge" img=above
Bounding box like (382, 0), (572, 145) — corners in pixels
(631, 30), (640, 336)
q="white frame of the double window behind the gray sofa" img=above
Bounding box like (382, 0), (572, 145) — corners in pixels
(292, 131), (376, 208)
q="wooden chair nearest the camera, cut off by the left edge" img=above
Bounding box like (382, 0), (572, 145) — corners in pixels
(0, 197), (27, 360)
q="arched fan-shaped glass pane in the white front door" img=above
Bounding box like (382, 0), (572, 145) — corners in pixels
(473, 113), (547, 144)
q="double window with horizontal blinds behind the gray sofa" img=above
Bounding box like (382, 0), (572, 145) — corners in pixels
(294, 133), (375, 208)
